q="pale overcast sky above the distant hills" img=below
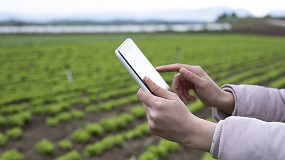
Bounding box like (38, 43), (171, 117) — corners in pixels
(0, 0), (285, 16)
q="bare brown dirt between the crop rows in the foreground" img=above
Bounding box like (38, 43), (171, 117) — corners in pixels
(0, 102), (210, 160)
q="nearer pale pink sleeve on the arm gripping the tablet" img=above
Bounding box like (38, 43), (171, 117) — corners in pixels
(211, 116), (285, 160)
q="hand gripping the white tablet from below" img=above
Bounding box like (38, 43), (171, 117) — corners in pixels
(137, 78), (216, 151)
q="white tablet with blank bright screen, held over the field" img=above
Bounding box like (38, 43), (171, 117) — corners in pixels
(115, 38), (169, 93)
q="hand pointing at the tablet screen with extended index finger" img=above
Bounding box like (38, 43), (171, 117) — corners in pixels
(156, 64), (234, 114)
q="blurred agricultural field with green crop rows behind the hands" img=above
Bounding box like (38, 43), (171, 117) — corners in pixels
(0, 33), (285, 160)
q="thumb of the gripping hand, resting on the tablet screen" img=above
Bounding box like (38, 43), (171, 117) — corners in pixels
(144, 77), (174, 99)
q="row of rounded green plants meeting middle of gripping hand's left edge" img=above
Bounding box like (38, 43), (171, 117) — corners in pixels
(32, 106), (145, 155)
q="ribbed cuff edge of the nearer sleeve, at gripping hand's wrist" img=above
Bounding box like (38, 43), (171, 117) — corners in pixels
(210, 120), (223, 158)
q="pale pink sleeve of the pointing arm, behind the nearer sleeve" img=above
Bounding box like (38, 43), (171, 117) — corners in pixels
(212, 85), (285, 122)
